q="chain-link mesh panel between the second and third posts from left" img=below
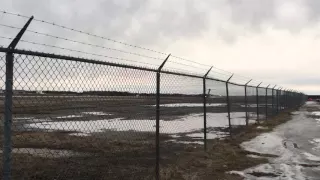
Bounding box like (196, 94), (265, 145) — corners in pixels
(160, 73), (204, 179)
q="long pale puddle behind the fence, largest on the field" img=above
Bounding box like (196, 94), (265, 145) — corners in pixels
(25, 112), (251, 139)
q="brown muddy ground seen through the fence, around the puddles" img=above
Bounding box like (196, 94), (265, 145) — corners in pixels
(1, 96), (282, 180)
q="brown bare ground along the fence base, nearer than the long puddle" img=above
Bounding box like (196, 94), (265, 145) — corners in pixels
(0, 107), (296, 180)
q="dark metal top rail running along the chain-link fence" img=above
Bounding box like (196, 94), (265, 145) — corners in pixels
(0, 47), (284, 88)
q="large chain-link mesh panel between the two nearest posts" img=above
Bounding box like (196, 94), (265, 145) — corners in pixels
(12, 55), (156, 179)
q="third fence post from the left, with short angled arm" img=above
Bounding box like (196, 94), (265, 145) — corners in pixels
(203, 67), (212, 151)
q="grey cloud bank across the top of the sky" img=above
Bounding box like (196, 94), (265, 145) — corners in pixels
(5, 0), (320, 46)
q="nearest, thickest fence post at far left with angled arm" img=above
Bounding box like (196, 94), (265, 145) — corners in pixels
(3, 16), (33, 180)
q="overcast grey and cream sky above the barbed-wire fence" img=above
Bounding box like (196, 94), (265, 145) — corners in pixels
(0, 0), (320, 94)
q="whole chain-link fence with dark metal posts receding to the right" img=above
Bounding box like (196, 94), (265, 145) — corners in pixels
(0, 16), (305, 179)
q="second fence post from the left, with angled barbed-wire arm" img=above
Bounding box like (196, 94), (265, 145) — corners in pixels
(155, 54), (170, 180)
